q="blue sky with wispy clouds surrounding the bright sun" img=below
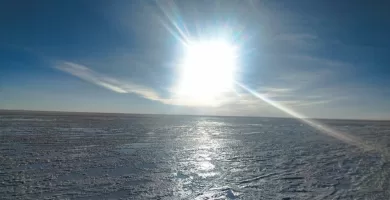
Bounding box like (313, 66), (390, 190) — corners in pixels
(0, 0), (390, 119)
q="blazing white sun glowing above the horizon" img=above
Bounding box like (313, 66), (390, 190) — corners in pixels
(175, 40), (237, 105)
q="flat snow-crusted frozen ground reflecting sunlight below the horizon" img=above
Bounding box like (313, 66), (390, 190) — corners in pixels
(0, 113), (390, 200)
